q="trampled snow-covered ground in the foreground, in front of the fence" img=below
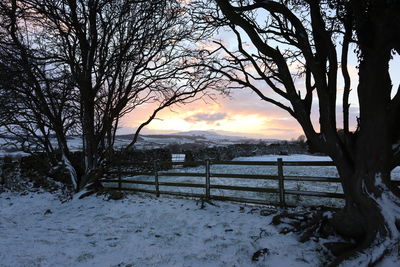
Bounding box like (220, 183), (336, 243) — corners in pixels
(0, 193), (334, 267)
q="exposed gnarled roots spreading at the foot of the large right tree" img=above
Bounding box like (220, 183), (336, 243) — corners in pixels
(271, 208), (400, 267)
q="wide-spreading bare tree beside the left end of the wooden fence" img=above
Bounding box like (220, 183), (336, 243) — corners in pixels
(0, 0), (210, 192)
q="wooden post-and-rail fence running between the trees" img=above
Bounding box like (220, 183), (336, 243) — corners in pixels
(101, 158), (400, 207)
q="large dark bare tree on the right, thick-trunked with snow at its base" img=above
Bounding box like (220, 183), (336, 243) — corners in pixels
(193, 0), (400, 265)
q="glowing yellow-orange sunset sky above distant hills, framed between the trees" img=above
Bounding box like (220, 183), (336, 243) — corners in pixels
(122, 90), (302, 139)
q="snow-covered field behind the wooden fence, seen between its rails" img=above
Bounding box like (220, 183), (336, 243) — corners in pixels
(109, 155), (400, 207)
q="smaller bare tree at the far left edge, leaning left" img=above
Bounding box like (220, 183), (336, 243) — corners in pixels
(0, 1), (77, 186)
